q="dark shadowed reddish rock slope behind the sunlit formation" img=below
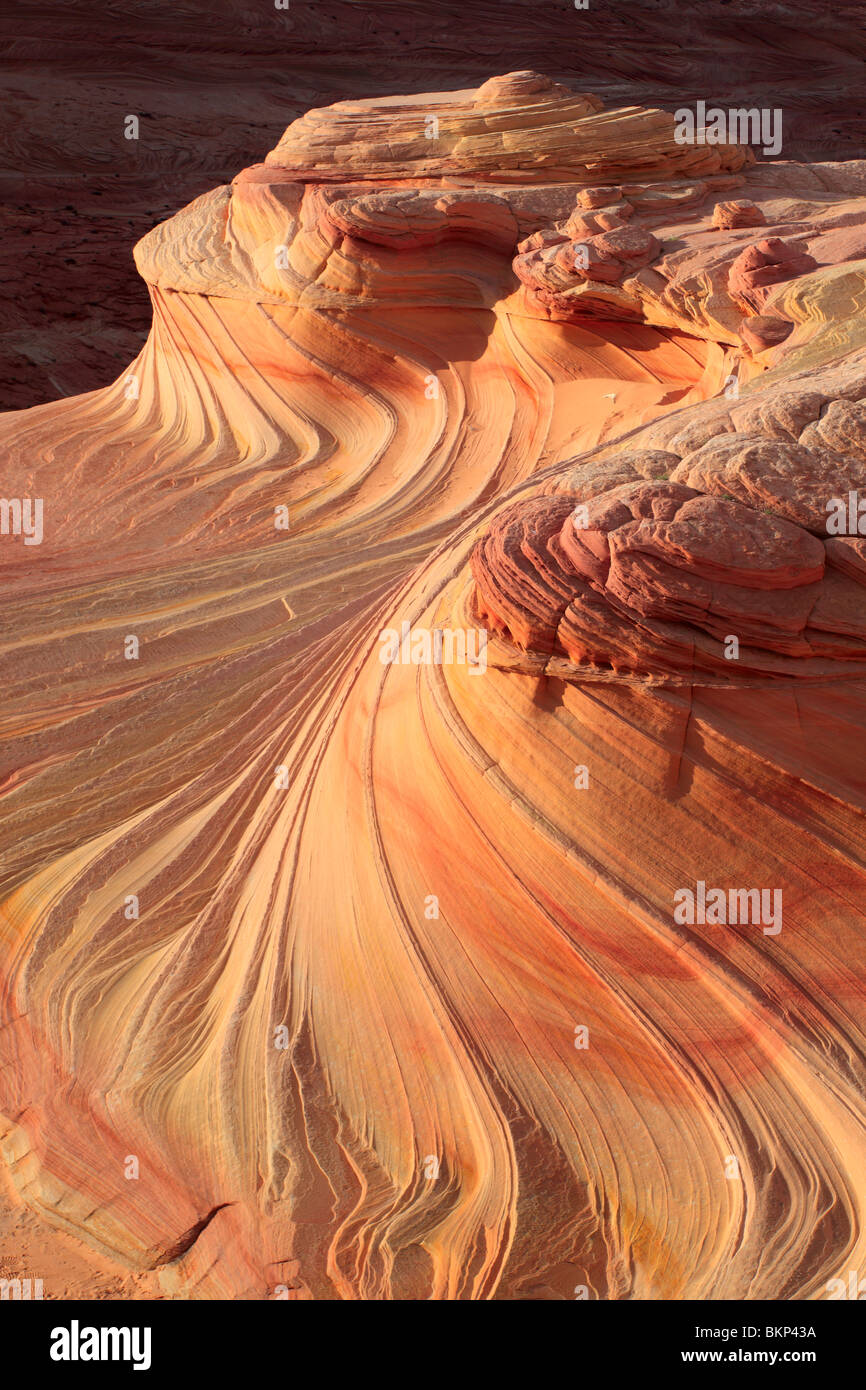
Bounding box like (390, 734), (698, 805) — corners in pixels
(6, 0), (866, 409)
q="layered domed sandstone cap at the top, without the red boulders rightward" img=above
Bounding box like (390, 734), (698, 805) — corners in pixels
(136, 72), (753, 315)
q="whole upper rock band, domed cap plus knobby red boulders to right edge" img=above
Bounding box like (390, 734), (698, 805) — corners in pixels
(135, 72), (866, 367)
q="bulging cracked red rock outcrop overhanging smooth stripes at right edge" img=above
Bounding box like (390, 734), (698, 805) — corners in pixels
(471, 371), (866, 685)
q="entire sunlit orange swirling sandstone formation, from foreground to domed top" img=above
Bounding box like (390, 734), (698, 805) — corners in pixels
(0, 74), (866, 1300)
